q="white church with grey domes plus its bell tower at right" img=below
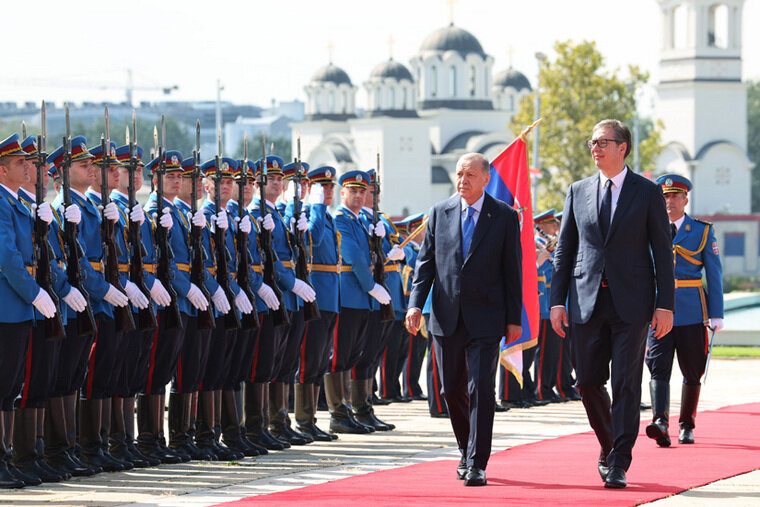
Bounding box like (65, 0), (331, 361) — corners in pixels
(291, 0), (760, 276)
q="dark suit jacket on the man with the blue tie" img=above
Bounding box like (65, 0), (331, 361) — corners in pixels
(409, 194), (522, 338)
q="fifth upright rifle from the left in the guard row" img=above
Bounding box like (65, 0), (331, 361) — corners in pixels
(153, 120), (183, 329)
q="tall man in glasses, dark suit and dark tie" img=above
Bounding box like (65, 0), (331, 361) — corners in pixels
(550, 120), (674, 488)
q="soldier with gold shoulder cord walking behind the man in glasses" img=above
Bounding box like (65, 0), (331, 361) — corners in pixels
(646, 174), (723, 447)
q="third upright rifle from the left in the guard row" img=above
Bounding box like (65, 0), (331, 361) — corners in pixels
(100, 106), (135, 331)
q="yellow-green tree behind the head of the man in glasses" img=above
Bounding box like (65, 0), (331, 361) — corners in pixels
(510, 41), (662, 209)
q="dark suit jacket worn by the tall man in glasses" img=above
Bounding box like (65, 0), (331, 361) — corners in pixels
(551, 169), (675, 324)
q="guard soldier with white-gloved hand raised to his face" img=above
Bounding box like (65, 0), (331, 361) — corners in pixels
(291, 166), (341, 442)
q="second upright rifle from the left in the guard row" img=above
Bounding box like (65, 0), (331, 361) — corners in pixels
(61, 102), (98, 336)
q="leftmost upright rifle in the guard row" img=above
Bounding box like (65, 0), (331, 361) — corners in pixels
(32, 100), (66, 340)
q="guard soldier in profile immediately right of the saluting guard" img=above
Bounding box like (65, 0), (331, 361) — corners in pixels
(324, 171), (391, 433)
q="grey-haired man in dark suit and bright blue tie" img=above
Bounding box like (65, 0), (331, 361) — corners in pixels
(406, 153), (522, 486)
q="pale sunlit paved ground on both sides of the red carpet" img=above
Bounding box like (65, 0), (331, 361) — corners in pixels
(0, 359), (760, 507)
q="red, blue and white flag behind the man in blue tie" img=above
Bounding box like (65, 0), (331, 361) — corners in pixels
(486, 137), (540, 386)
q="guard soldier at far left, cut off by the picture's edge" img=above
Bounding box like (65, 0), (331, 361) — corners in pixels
(0, 134), (56, 489)
